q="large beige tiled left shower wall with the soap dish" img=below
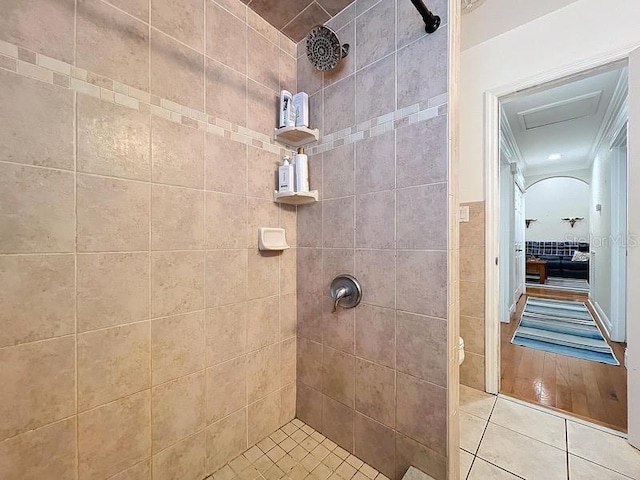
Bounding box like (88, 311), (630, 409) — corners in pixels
(0, 0), (296, 480)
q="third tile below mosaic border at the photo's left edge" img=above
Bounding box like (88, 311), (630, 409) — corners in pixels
(0, 255), (75, 347)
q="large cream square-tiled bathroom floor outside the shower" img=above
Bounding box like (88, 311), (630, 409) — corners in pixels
(460, 385), (640, 480)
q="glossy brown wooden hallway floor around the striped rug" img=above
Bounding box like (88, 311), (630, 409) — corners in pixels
(500, 287), (627, 432)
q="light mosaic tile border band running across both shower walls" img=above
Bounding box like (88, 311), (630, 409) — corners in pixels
(0, 40), (448, 160)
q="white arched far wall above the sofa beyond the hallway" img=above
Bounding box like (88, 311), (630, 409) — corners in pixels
(525, 177), (591, 242)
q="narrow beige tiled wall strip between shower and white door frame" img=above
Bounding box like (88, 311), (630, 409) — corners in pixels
(460, 202), (485, 391)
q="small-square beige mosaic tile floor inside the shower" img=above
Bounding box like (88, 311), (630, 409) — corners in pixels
(205, 418), (389, 480)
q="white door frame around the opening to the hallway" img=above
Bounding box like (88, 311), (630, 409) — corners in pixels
(484, 45), (640, 443)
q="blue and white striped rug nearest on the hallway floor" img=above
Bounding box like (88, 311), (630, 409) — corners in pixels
(511, 297), (620, 365)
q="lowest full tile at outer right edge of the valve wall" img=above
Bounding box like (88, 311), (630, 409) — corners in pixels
(396, 373), (447, 456)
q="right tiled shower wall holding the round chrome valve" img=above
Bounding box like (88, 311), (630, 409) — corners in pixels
(297, 0), (457, 479)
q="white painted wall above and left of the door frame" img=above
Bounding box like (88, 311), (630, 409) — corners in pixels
(459, 0), (640, 202)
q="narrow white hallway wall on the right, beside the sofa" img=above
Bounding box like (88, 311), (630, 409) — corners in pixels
(589, 145), (611, 318)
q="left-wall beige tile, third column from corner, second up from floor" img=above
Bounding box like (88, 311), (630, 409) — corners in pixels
(206, 356), (247, 424)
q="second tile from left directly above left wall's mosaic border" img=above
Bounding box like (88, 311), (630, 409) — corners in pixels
(76, 0), (149, 91)
